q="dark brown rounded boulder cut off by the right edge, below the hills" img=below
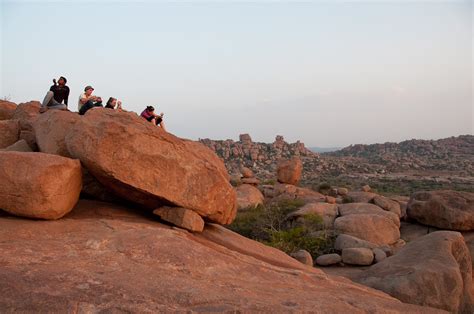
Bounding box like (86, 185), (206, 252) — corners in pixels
(407, 190), (474, 231)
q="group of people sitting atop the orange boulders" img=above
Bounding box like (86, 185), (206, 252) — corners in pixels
(40, 76), (166, 131)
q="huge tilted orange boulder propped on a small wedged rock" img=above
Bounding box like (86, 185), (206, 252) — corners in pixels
(66, 109), (237, 224)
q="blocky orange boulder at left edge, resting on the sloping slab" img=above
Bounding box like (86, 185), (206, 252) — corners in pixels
(0, 152), (82, 219)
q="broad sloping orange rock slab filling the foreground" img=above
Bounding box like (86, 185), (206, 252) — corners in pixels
(0, 201), (441, 313)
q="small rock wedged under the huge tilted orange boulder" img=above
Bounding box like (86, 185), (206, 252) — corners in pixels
(153, 206), (204, 232)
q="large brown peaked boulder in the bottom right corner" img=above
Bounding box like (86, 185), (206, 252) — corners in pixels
(356, 231), (474, 313)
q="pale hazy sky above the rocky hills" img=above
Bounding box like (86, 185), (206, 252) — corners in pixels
(0, 0), (474, 147)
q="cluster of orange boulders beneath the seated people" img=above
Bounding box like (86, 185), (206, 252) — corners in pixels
(0, 101), (236, 231)
